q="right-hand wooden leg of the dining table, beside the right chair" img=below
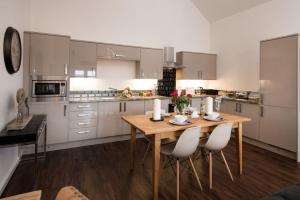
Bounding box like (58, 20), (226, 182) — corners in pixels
(235, 123), (243, 175)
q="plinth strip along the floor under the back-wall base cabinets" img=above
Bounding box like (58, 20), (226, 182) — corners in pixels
(21, 134), (144, 155)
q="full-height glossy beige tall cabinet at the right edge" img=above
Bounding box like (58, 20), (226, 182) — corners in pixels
(260, 35), (299, 152)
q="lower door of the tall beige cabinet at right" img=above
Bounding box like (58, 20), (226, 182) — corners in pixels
(260, 106), (297, 152)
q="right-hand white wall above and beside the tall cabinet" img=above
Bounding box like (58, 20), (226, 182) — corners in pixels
(210, 0), (300, 91)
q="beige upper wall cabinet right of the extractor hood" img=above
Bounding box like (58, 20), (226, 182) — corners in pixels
(176, 52), (217, 80)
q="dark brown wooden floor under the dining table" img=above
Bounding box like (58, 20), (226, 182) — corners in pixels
(3, 139), (300, 200)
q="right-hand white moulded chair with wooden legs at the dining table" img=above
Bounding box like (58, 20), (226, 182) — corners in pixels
(200, 123), (233, 189)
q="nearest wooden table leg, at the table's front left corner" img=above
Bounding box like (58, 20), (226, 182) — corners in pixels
(153, 134), (161, 200)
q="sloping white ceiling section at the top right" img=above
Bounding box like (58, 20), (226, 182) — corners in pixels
(192, 0), (271, 22)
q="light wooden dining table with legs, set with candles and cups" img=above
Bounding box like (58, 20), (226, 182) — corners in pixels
(122, 113), (251, 200)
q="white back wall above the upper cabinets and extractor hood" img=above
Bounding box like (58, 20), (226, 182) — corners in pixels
(31, 0), (210, 52)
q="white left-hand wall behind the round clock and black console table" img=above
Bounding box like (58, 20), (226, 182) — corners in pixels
(0, 0), (29, 194)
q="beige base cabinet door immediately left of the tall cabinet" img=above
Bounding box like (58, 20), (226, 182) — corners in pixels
(239, 103), (260, 140)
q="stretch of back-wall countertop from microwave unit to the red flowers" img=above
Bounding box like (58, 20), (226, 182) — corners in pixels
(69, 96), (170, 103)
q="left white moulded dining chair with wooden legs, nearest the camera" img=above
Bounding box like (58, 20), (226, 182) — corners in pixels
(161, 127), (202, 200)
